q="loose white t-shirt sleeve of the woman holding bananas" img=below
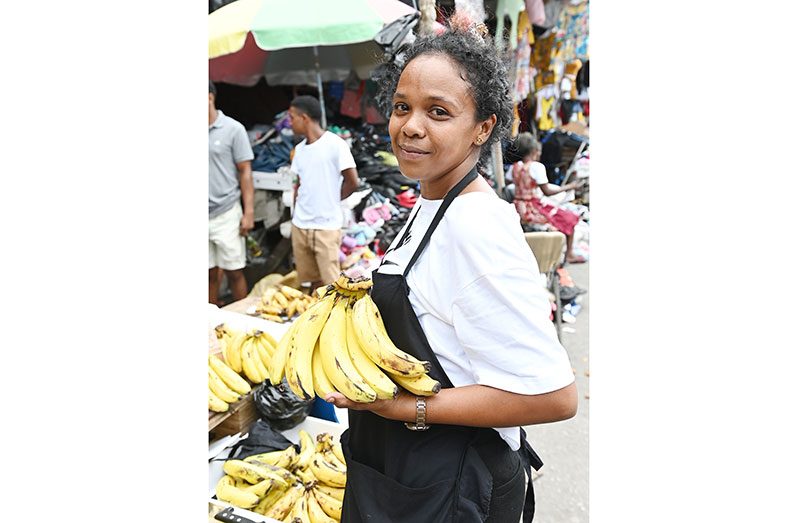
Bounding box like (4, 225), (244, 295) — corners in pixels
(452, 268), (574, 394)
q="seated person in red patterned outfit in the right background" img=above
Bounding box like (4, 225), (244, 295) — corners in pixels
(513, 133), (585, 263)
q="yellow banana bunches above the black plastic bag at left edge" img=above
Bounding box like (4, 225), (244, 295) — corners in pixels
(208, 324), (277, 412)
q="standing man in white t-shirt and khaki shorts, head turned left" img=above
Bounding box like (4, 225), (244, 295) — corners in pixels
(288, 96), (359, 292)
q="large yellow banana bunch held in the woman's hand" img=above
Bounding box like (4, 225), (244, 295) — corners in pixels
(269, 273), (441, 402)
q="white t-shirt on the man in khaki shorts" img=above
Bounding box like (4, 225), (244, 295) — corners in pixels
(291, 131), (355, 230)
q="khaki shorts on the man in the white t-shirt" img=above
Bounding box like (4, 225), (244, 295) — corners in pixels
(291, 224), (341, 285)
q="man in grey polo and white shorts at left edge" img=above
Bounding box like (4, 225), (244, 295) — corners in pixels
(208, 82), (255, 304)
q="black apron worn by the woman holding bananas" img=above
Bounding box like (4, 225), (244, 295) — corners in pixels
(341, 169), (543, 523)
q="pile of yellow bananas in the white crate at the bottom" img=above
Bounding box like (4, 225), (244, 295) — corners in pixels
(216, 430), (346, 523)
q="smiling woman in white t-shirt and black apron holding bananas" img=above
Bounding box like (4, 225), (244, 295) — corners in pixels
(326, 15), (577, 523)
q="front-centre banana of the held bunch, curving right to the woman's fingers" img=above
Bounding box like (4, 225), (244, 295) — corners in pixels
(314, 297), (377, 404)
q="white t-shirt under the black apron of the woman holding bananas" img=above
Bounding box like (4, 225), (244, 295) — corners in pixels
(378, 192), (574, 450)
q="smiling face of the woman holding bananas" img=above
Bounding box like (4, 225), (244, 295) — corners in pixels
(388, 54), (496, 199)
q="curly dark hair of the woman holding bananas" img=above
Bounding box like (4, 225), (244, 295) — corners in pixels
(372, 27), (513, 170)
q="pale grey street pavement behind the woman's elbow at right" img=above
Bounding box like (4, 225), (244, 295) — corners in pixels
(525, 263), (590, 523)
